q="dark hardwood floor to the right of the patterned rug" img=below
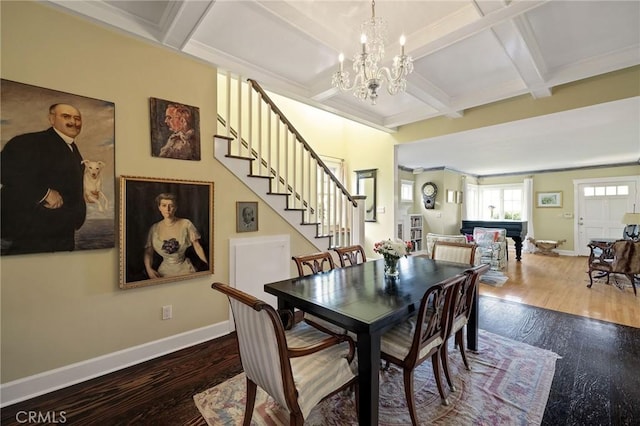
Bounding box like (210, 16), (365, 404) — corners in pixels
(479, 296), (640, 426)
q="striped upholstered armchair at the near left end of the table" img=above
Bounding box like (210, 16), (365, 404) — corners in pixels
(211, 282), (358, 425)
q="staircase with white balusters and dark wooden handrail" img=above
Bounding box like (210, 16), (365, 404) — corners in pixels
(214, 73), (364, 251)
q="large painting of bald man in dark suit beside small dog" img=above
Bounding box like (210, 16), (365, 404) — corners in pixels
(0, 79), (116, 255)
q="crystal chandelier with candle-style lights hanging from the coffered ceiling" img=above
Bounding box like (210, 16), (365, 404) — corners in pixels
(331, 0), (413, 105)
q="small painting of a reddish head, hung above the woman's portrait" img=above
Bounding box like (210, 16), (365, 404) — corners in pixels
(149, 98), (200, 161)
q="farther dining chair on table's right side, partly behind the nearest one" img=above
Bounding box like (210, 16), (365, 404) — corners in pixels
(440, 263), (490, 392)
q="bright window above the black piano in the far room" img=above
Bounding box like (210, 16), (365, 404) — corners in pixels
(477, 184), (524, 220)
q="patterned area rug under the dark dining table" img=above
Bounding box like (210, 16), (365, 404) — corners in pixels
(193, 330), (559, 426)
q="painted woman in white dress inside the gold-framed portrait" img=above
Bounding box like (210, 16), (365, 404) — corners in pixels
(144, 192), (208, 278)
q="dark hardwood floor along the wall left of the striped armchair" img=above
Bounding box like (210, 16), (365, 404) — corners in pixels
(0, 334), (242, 426)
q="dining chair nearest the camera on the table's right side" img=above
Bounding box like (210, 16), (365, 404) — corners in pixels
(380, 274), (466, 425)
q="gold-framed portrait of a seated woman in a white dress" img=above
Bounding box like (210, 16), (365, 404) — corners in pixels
(120, 176), (214, 289)
